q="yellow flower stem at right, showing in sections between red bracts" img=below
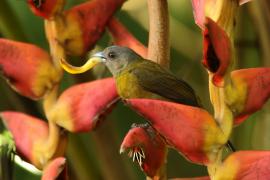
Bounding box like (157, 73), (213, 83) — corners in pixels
(204, 1), (238, 179)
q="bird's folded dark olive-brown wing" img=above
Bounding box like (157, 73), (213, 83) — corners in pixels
(130, 60), (201, 107)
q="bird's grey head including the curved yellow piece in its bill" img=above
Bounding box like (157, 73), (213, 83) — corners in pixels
(61, 46), (141, 76)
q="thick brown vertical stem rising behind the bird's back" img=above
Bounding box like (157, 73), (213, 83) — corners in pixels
(148, 0), (170, 67)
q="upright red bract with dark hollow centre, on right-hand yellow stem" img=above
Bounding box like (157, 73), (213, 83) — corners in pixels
(202, 18), (232, 87)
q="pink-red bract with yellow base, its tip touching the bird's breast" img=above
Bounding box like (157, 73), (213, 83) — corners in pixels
(50, 78), (119, 132)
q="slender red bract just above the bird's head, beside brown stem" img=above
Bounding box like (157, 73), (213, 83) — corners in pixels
(108, 18), (147, 58)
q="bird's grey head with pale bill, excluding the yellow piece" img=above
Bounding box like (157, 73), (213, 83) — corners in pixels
(92, 46), (141, 76)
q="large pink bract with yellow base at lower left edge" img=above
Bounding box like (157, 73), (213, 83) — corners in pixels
(0, 111), (66, 169)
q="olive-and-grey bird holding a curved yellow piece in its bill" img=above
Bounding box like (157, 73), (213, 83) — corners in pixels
(60, 46), (235, 151)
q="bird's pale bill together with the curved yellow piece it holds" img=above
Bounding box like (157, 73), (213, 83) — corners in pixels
(60, 52), (106, 74)
